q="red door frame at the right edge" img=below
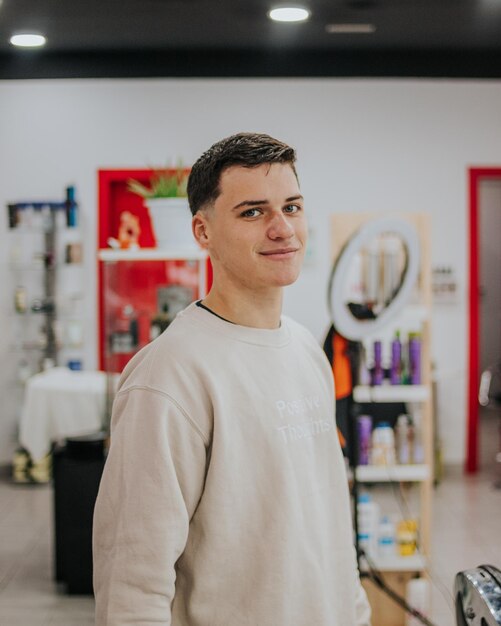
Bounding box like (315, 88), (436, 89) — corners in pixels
(465, 167), (501, 474)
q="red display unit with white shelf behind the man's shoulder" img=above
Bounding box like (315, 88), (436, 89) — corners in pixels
(97, 169), (211, 382)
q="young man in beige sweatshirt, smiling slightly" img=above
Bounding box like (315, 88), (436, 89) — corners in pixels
(94, 133), (370, 626)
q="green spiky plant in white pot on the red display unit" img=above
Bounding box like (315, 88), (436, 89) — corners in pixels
(127, 167), (195, 248)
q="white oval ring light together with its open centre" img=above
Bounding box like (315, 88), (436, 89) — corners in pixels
(328, 218), (420, 341)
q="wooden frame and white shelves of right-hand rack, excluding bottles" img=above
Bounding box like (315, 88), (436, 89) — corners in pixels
(331, 214), (434, 626)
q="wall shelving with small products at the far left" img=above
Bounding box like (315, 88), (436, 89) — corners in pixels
(4, 197), (84, 482)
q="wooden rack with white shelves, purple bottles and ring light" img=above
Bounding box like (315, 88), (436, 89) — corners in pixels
(330, 213), (433, 626)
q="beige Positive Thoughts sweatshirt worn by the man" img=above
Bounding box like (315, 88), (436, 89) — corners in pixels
(94, 304), (370, 626)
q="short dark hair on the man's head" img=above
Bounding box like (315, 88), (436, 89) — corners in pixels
(188, 133), (297, 215)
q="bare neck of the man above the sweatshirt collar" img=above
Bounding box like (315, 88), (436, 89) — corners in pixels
(202, 286), (282, 329)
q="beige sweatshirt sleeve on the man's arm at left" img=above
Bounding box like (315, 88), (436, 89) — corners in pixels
(93, 388), (207, 626)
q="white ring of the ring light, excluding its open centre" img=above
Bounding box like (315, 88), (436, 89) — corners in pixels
(328, 218), (420, 341)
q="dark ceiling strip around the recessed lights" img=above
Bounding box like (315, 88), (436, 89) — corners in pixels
(0, 0), (501, 79)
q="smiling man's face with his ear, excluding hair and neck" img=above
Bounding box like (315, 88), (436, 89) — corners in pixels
(193, 163), (307, 291)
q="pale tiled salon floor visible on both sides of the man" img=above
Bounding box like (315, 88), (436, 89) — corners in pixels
(0, 412), (501, 626)
